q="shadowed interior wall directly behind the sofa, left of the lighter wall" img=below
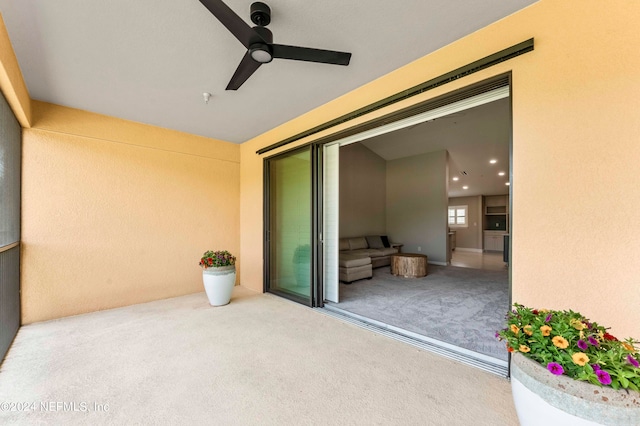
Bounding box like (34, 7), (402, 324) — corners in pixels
(340, 143), (387, 238)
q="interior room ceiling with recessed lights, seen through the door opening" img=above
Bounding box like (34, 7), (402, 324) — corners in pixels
(363, 98), (511, 197)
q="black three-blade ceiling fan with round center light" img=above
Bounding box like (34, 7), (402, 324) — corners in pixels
(200, 0), (351, 90)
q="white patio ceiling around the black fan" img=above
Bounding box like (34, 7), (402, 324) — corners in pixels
(0, 0), (535, 143)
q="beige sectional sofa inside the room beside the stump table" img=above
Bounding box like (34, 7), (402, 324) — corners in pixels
(339, 235), (398, 283)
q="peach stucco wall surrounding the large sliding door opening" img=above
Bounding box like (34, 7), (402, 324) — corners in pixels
(240, 0), (640, 337)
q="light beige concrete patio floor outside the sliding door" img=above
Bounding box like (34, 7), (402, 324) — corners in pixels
(0, 287), (518, 426)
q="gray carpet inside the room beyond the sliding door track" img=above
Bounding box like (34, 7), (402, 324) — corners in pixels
(331, 265), (509, 361)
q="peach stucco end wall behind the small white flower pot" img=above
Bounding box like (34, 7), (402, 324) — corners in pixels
(21, 102), (242, 323)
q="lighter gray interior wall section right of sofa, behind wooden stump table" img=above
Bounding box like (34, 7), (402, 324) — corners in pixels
(387, 151), (448, 265)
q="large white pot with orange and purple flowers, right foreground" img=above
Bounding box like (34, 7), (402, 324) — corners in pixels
(496, 303), (640, 425)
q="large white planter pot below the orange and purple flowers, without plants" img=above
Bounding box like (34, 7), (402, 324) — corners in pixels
(511, 353), (640, 426)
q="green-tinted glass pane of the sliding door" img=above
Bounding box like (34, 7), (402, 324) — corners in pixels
(265, 147), (313, 305)
